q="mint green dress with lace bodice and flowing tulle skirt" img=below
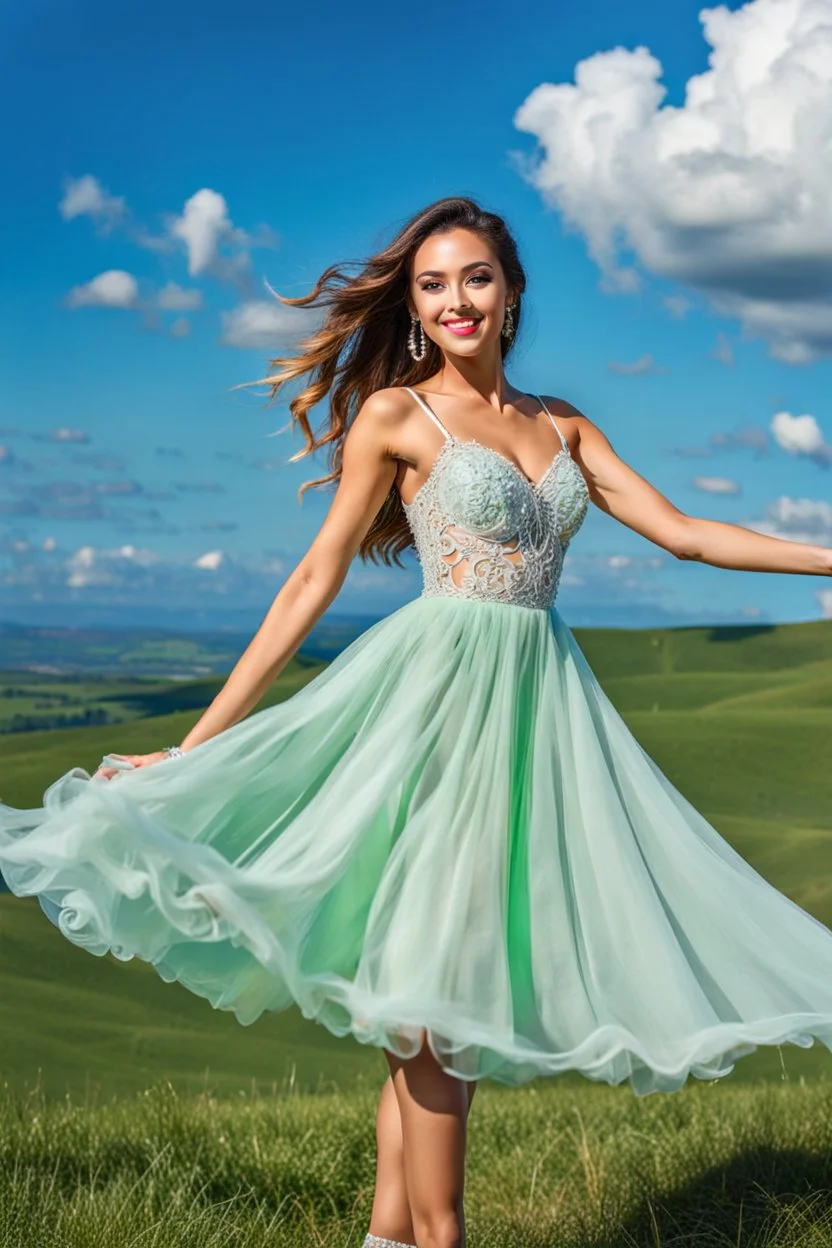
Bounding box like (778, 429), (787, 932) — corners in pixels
(0, 379), (832, 1096)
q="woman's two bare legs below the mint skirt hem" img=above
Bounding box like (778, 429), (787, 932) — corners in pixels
(370, 1033), (475, 1248)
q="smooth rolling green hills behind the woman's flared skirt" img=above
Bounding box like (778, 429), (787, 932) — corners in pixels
(0, 622), (832, 1094)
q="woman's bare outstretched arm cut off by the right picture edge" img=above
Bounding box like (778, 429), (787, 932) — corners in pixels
(568, 402), (832, 577)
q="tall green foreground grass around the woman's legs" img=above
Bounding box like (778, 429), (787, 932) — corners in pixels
(0, 1075), (832, 1248)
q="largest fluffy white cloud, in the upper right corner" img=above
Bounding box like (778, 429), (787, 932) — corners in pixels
(514, 0), (832, 364)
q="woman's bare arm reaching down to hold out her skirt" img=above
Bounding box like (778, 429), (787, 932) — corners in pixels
(99, 391), (403, 779)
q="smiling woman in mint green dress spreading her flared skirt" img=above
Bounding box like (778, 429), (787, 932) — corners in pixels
(0, 198), (832, 1248)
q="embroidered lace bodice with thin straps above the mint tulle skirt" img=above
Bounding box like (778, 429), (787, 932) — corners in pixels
(402, 386), (589, 610)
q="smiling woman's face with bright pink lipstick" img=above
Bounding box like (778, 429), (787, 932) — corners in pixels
(410, 230), (513, 356)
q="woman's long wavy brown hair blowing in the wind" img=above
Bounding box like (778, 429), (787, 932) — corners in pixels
(233, 196), (526, 567)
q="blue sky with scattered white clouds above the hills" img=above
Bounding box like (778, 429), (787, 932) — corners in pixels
(0, 0), (832, 625)
